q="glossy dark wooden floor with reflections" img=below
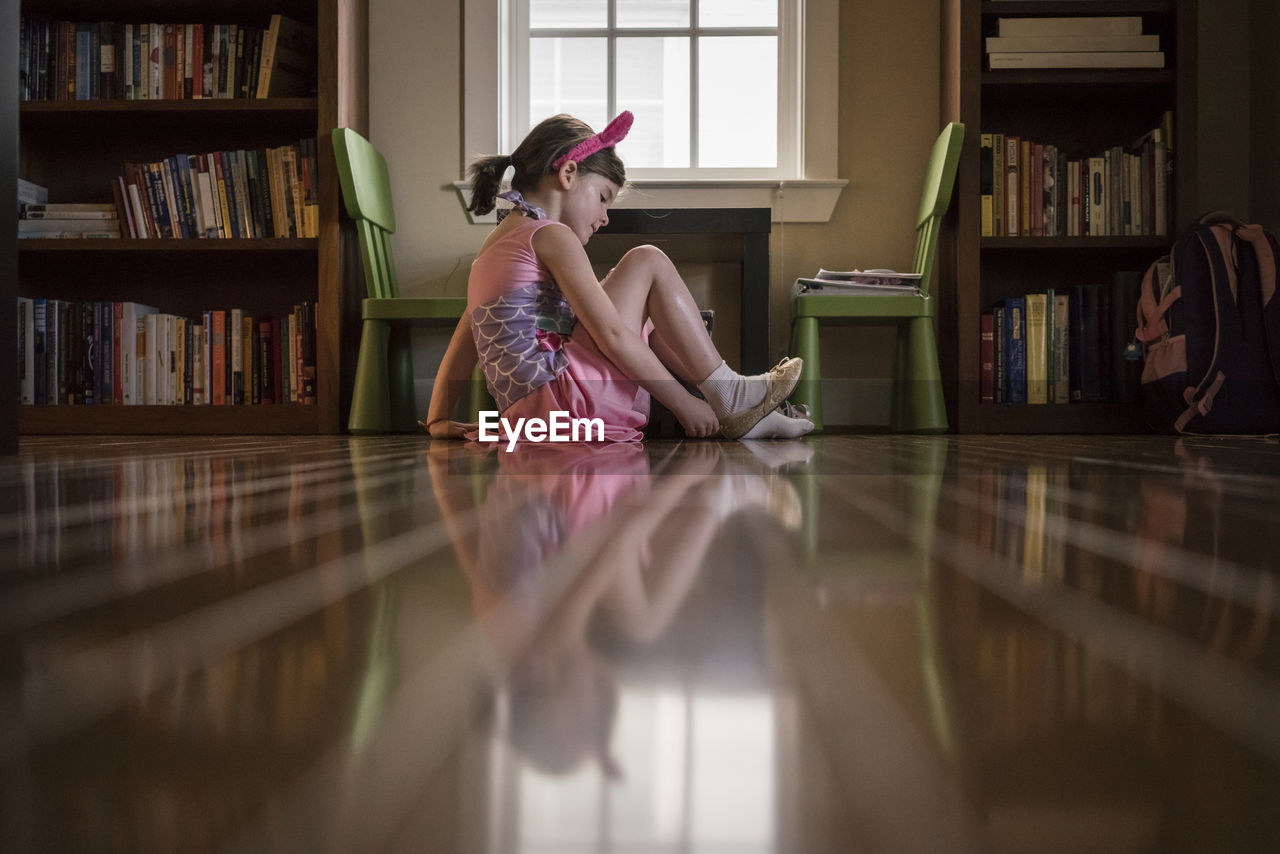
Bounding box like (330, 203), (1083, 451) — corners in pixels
(0, 435), (1280, 854)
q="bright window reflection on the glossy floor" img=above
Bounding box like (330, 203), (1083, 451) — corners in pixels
(504, 682), (780, 854)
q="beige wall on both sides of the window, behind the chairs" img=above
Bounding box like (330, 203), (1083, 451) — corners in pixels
(370, 0), (940, 425)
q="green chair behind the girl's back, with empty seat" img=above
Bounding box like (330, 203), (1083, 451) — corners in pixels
(333, 128), (493, 433)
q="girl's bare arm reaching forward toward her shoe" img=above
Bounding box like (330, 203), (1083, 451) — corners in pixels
(534, 228), (719, 438)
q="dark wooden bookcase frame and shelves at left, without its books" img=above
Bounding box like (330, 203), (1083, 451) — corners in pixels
(18, 0), (369, 434)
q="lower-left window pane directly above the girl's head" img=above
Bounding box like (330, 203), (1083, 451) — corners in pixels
(529, 38), (609, 131)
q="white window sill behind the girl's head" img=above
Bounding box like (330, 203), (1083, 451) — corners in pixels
(453, 178), (849, 224)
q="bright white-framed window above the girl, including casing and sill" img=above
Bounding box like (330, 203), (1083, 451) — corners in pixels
(454, 0), (847, 222)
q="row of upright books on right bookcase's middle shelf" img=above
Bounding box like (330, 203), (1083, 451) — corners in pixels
(979, 113), (1172, 237)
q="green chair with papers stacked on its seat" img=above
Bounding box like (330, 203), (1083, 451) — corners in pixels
(791, 122), (964, 433)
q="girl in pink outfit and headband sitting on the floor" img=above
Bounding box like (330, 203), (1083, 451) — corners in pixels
(426, 111), (813, 442)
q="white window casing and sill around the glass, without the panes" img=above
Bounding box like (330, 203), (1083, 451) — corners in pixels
(454, 0), (849, 222)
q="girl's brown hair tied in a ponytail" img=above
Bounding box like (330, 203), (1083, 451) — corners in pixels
(467, 114), (627, 214)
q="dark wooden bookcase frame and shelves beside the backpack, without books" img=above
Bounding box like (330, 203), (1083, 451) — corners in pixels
(940, 0), (1197, 433)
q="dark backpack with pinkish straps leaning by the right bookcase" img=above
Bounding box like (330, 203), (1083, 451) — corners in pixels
(1135, 213), (1280, 434)
